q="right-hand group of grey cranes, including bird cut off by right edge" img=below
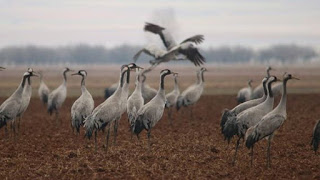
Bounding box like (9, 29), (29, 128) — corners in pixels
(220, 67), (320, 167)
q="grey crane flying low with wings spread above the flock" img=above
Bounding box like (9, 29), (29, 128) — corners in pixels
(133, 23), (205, 66)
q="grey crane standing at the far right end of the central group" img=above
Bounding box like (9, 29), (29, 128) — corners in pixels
(176, 67), (207, 117)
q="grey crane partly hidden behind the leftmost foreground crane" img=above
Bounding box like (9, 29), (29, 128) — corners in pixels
(18, 68), (34, 130)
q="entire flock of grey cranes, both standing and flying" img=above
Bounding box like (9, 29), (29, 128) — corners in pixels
(0, 23), (320, 172)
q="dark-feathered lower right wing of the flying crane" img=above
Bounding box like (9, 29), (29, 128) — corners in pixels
(179, 46), (206, 66)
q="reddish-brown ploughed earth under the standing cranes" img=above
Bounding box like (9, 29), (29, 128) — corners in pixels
(0, 95), (320, 179)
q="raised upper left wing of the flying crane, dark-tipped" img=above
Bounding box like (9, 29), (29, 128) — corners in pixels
(144, 22), (177, 50)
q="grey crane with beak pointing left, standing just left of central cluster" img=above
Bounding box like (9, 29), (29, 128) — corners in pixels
(71, 70), (94, 134)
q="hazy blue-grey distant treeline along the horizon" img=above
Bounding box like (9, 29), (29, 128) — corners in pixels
(0, 44), (319, 65)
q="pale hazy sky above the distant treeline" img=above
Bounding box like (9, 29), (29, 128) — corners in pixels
(0, 0), (320, 47)
